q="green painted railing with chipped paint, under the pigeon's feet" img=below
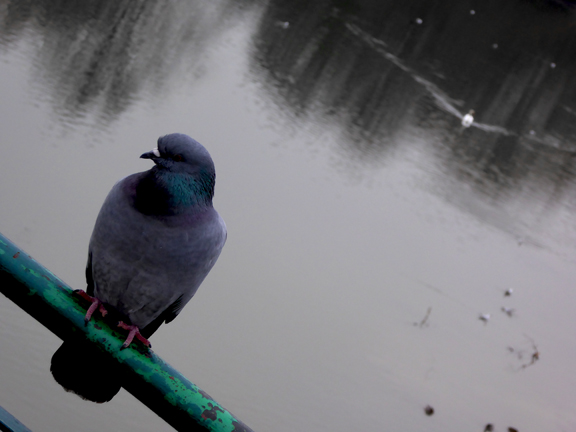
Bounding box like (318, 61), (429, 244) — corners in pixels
(0, 234), (251, 432)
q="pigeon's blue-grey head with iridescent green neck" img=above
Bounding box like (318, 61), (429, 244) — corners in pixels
(140, 133), (216, 207)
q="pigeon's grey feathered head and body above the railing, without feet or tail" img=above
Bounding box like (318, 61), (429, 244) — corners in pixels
(86, 134), (226, 329)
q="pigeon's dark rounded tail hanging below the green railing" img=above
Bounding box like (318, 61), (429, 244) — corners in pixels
(50, 338), (122, 403)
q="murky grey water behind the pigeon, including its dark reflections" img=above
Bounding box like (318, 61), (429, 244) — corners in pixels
(0, 0), (576, 432)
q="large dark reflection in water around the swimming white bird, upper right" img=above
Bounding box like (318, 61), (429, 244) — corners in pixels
(254, 0), (576, 248)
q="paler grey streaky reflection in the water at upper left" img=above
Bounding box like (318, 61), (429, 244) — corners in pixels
(0, 0), (254, 126)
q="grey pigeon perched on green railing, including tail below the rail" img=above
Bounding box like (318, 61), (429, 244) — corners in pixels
(51, 133), (227, 403)
